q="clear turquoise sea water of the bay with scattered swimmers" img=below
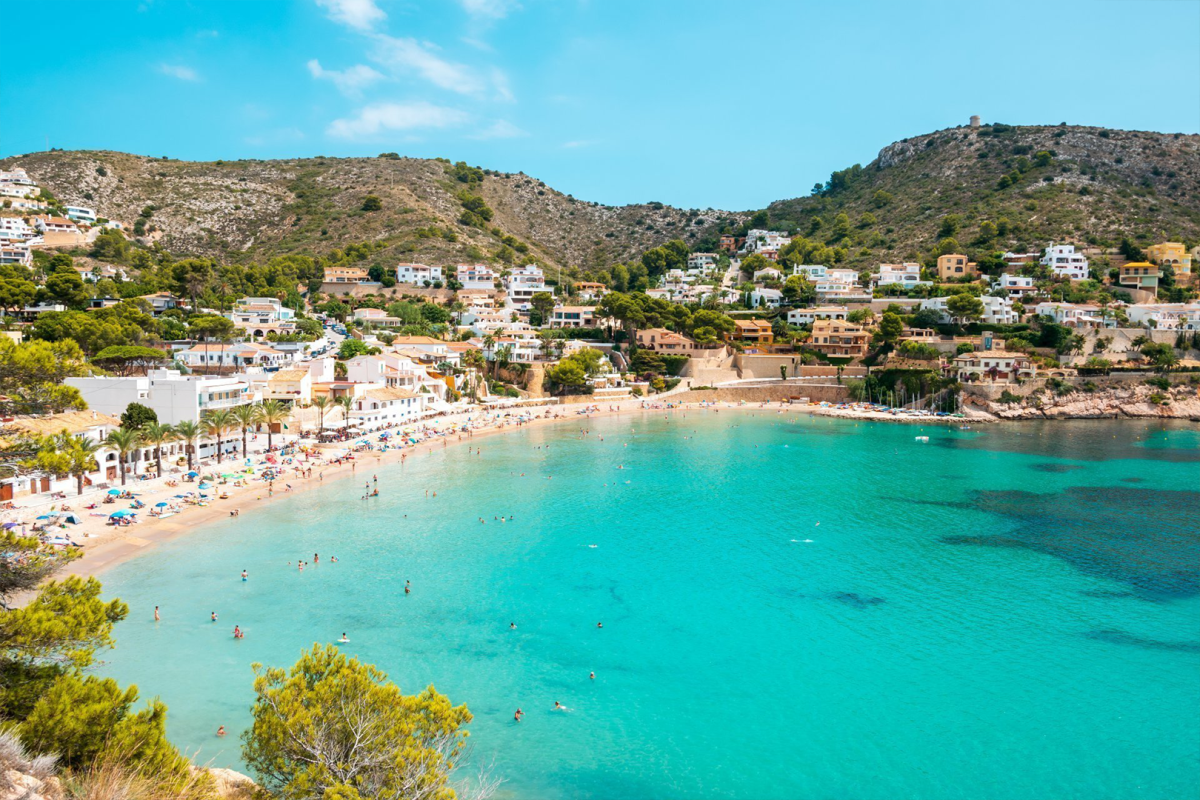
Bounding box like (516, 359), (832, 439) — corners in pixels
(96, 411), (1200, 800)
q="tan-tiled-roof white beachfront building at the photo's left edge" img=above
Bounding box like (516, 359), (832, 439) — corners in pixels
(0, 410), (121, 503)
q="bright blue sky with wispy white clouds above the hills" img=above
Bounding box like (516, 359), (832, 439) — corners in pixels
(0, 0), (1200, 209)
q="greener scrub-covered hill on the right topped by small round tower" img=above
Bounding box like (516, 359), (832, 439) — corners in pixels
(760, 125), (1200, 266)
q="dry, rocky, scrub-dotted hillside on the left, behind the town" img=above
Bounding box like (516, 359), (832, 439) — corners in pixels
(0, 151), (744, 267)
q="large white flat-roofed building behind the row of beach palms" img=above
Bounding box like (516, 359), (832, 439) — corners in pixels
(62, 369), (259, 425)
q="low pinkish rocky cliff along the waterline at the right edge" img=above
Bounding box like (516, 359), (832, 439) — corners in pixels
(976, 384), (1200, 420)
